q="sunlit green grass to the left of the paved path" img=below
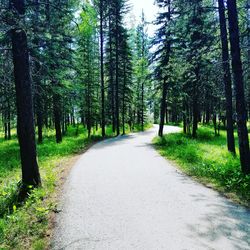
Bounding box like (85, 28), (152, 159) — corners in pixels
(0, 125), (151, 250)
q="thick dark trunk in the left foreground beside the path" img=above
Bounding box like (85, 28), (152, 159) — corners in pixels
(10, 0), (41, 187)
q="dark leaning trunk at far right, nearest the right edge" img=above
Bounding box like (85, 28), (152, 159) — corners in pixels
(227, 0), (250, 174)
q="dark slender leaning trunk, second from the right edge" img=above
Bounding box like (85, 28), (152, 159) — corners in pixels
(218, 0), (235, 154)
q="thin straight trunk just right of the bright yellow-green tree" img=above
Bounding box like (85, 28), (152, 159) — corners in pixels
(100, 0), (105, 137)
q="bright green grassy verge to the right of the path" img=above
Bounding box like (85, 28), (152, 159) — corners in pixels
(154, 127), (250, 206)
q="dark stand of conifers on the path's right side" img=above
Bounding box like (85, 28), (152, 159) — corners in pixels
(153, 0), (250, 174)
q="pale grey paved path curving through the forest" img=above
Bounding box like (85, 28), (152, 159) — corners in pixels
(52, 127), (250, 250)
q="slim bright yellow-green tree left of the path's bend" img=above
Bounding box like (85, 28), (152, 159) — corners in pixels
(77, 3), (99, 137)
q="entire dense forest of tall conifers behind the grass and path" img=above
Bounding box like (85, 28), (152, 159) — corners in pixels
(0, 0), (250, 195)
